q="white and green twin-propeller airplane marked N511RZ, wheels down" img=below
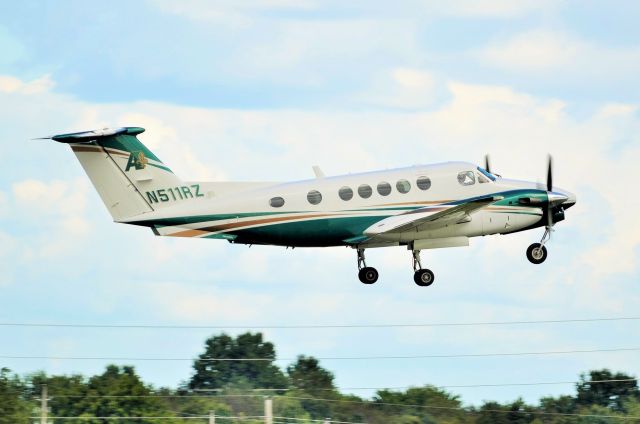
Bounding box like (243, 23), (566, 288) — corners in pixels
(44, 127), (576, 286)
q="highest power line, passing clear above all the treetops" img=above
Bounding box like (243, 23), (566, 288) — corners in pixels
(0, 316), (640, 330)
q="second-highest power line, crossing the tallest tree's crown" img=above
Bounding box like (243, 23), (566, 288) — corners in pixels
(0, 347), (640, 362)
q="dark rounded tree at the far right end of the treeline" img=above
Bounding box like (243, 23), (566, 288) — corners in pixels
(576, 369), (640, 412)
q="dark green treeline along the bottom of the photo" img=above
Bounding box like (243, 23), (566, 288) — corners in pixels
(0, 333), (640, 424)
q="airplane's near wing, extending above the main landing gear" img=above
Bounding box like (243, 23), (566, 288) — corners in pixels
(364, 196), (504, 237)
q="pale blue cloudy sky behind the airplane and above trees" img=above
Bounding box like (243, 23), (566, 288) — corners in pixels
(0, 0), (640, 404)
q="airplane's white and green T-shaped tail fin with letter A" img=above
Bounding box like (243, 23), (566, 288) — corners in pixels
(51, 127), (203, 221)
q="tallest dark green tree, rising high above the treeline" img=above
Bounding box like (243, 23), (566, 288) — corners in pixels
(189, 333), (287, 389)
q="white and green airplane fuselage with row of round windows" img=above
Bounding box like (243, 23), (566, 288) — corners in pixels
(124, 162), (573, 247)
